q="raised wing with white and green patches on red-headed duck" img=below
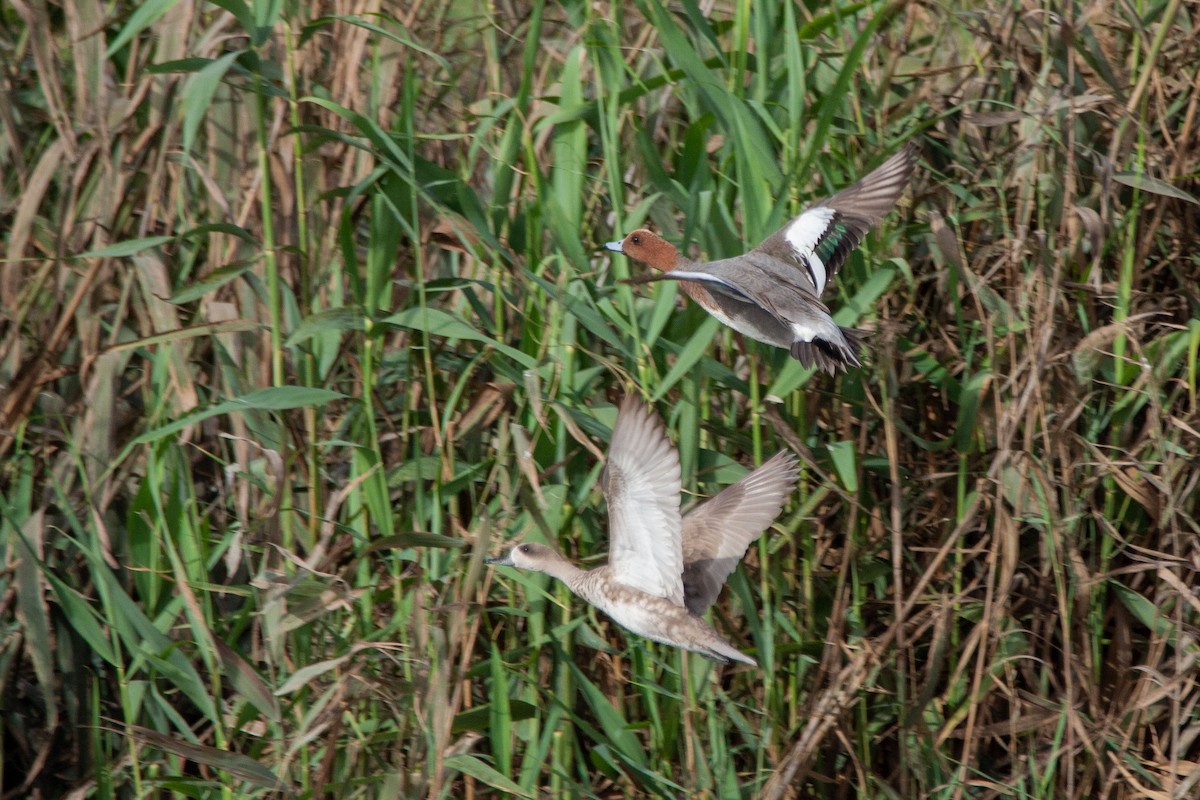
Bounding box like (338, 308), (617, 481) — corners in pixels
(751, 142), (917, 297)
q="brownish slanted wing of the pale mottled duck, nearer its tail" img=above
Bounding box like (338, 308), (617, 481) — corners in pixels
(683, 451), (797, 616)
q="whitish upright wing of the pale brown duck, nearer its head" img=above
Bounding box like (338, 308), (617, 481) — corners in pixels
(601, 395), (683, 606)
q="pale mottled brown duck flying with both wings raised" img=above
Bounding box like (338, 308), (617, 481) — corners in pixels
(487, 396), (797, 666)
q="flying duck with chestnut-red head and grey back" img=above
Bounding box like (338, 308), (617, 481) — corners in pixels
(605, 144), (917, 373)
